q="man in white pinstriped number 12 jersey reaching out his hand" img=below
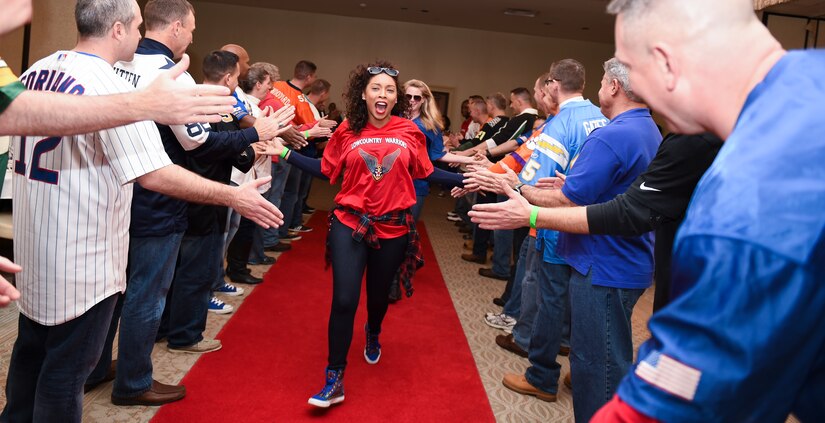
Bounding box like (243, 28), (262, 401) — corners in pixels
(0, 0), (282, 422)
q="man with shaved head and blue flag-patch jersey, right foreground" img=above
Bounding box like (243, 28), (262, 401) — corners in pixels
(588, 0), (825, 422)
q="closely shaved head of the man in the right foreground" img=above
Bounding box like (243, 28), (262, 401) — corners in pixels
(607, 0), (781, 138)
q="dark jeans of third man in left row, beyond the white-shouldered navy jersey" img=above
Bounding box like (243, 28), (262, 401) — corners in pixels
(159, 232), (223, 347)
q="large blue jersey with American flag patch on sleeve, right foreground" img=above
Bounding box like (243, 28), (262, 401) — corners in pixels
(618, 50), (825, 422)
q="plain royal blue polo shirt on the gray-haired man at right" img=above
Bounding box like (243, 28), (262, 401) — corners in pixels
(558, 108), (662, 289)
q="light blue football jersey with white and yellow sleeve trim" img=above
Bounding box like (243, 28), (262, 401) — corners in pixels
(519, 97), (608, 264)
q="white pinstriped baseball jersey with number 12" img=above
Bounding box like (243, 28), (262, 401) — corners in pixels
(12, 51), (171, 326)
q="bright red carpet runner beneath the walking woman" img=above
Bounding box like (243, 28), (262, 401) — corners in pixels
(153, 212), (495, 423)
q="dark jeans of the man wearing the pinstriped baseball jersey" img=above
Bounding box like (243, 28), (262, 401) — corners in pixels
(0, 294), (120, 422)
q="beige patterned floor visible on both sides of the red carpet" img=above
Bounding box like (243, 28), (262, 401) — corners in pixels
(0, 185), (792, 422)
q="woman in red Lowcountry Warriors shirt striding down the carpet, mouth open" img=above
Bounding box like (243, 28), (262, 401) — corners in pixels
(276, 61), (462, 408)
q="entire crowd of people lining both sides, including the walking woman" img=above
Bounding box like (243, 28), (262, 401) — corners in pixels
(0, 0), (825, 422)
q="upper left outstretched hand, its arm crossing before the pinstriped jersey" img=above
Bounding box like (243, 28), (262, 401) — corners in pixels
(142, 54), (236, 125)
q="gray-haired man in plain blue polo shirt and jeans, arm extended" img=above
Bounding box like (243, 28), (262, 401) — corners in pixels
(480, 58), (662, 422)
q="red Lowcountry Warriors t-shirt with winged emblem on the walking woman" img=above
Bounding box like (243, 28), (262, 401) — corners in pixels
(321, 116), (433, 239)
